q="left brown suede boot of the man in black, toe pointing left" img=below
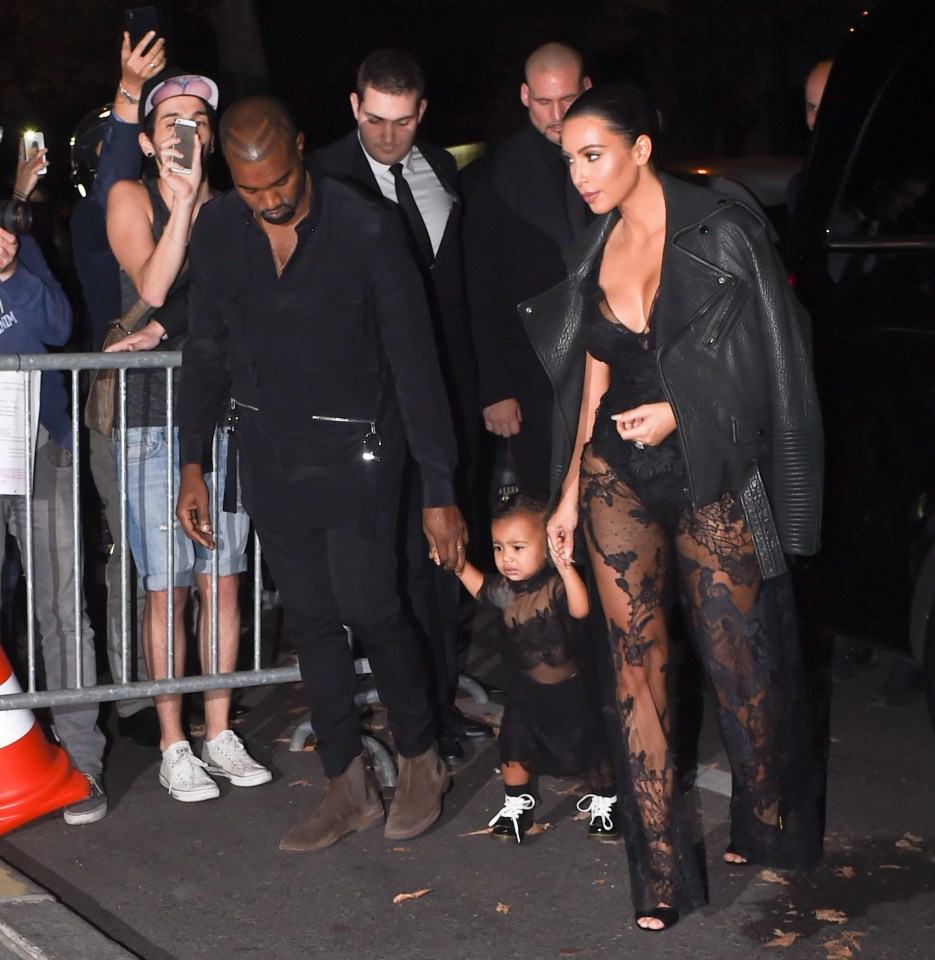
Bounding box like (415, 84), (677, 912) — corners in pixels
(279, 754), (383, 852)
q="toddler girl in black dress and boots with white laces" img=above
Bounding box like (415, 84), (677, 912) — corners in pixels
(459, 495), (620, 843)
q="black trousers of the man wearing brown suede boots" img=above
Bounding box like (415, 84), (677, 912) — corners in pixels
(241, 430), (435, 779)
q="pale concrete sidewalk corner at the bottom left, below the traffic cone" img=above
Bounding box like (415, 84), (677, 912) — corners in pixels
(0, 860), (138, 960)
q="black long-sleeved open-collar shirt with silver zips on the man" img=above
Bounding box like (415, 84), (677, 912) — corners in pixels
(179, 167), (456, 526)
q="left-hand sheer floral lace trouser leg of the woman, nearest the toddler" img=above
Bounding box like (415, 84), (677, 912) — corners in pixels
(581, 453), (704, 916)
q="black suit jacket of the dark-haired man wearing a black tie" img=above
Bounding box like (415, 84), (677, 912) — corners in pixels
(315, 130), (477, 442)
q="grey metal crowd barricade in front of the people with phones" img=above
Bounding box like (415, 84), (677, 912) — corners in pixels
(0, 351), (300, 710)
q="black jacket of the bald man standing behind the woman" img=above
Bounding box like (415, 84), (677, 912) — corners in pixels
(461, 124), (591, 407)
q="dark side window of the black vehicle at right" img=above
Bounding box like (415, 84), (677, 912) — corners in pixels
(827, 37), (935, 304)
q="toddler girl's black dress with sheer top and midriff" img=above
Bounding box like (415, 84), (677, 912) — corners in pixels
(477, 567), (613, 795)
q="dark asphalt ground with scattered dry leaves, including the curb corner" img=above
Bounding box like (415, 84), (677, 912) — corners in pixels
(0, 632), (935, 960)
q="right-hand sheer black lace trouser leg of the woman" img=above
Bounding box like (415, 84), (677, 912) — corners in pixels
(676, 494), (805, 866)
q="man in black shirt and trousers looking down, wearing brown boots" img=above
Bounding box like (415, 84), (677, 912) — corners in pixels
(177, 97), (467, 850)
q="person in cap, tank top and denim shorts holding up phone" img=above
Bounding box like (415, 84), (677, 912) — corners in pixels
(107, 70), (272, 802)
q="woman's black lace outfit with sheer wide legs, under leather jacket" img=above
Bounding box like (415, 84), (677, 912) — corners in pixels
(579, 279), (820, 916)
